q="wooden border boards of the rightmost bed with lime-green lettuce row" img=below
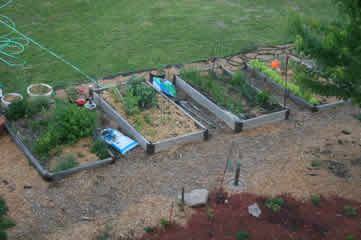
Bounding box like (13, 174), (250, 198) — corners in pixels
(247, 56), (347, 112)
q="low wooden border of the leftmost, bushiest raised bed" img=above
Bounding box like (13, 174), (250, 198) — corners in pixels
(5, 123), (115, 181)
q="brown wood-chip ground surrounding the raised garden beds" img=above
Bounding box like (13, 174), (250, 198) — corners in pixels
(0, 46), (361, 240)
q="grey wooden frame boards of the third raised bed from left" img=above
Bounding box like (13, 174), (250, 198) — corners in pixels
(173, 66), (289, 133)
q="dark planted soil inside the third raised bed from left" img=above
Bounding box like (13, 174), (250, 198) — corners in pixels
(180, 70), (283, 119)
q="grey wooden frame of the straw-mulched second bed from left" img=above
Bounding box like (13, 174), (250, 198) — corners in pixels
(93, 83), (208, 154)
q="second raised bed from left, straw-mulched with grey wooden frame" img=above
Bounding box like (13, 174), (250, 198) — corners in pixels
(93, 78), (208, 153)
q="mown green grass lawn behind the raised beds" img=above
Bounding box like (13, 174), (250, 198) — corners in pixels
(0, 0), (333, 90)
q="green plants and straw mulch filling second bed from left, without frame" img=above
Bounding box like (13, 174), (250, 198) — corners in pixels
(102, 77), (199, 142)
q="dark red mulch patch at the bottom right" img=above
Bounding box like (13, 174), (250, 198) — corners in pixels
(142, 193), (361, 240)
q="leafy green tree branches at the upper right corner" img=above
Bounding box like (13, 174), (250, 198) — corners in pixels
(288, 0), (361, 106)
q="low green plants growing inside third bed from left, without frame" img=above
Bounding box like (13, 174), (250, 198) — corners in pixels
(180, 69), (282, 119)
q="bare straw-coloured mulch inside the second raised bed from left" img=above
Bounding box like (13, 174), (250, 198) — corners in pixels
(102, 87), (201, 142)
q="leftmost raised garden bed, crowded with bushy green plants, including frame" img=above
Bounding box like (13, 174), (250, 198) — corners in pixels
(5, 95), (114, 180)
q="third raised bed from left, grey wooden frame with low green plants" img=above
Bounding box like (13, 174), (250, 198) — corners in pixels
(174, 66), (288, 132)
